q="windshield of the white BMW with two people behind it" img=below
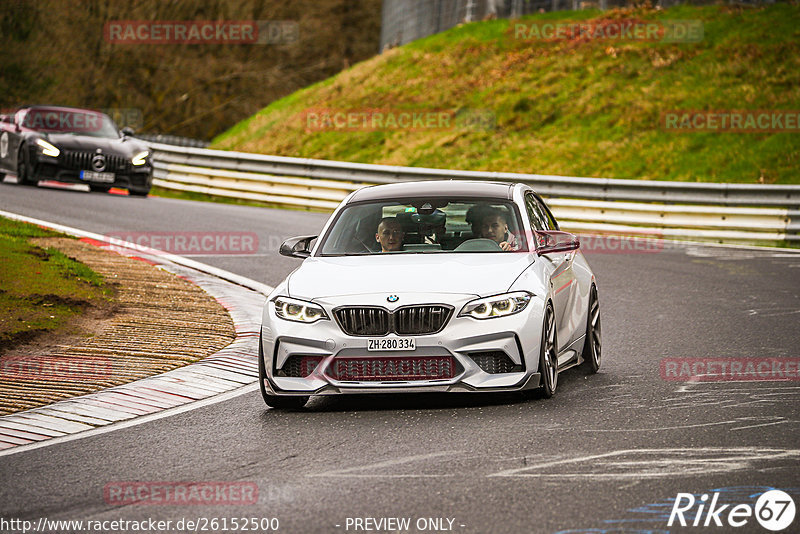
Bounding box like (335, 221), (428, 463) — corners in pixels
(320, 198), (528, 256)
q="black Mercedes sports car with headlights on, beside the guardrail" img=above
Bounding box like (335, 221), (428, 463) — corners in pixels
(0, 106), (153, 196)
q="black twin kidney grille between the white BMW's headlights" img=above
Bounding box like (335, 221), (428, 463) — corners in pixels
(333, 304), (453, 336)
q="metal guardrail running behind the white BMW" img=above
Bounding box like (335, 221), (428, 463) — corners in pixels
(150, 143), (800, 242)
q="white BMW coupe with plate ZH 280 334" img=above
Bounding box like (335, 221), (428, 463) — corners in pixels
(259, 180), (601, 408)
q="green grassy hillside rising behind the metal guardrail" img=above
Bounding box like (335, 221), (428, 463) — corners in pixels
(213, 3), (800, 183)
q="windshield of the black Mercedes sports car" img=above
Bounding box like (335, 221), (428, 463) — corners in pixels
(22, 108), (119, 139)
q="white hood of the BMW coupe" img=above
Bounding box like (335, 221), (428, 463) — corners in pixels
(288, 253), (534, 300)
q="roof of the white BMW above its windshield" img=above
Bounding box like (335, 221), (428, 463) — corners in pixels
(350, 180), (514, 202)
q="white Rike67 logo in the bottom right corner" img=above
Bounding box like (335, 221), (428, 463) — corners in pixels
(667, 490), (795, 532)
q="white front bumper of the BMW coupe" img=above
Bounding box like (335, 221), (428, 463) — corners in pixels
(261, 295), (543, 395)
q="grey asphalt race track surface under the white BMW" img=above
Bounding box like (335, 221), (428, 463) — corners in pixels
(0, 183), (800, 534)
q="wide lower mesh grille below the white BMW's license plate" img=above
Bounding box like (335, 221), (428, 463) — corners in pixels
(327, 356), (456, 382)
